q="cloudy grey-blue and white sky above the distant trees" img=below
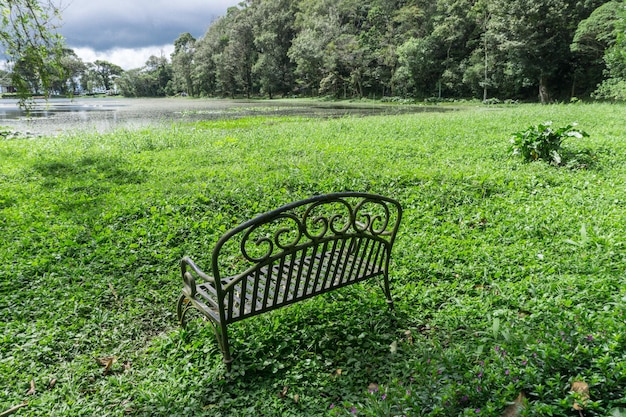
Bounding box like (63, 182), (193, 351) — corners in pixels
(57, 0), (240, 69)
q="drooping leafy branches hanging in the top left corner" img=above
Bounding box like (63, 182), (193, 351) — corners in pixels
(0, 0), (64, 107)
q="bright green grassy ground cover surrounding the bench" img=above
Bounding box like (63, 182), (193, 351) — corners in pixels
(0, 104), (626, 416)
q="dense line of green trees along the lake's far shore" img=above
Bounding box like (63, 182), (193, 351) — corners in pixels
(3, 0), (626, 103)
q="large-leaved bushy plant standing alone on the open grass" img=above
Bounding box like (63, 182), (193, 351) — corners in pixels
(511, 122), (589, 165)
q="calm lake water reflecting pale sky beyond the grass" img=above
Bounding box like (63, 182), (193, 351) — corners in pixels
(0, 97), (450, 135)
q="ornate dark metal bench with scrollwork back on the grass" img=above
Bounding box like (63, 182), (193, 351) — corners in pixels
(177, 192), (402, 368)
